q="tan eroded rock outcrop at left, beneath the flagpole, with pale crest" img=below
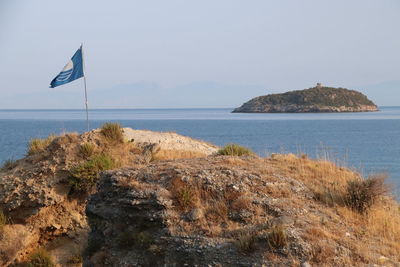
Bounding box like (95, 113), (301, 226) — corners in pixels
(0, 128), (217, 266)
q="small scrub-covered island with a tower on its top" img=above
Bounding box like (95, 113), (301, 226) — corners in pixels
(232, 83), (378, 113)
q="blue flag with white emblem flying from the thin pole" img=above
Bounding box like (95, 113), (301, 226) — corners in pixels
(50, 46), (84, 88)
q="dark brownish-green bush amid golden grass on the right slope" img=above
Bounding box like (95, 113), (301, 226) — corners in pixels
(344, 175), (388, 213)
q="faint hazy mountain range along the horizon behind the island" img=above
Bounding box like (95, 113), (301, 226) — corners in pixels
(0, 81), (400, 109)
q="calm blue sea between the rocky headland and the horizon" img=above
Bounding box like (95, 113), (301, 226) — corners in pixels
(0, 107), (400, 196)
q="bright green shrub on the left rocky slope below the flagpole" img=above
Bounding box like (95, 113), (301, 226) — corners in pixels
(69, 154), (116, 192)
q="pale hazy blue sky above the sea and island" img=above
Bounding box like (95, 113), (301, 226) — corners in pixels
(0, 0), (400, 109)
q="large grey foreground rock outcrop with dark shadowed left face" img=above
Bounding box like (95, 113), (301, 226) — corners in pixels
(85, 155), (399, 267)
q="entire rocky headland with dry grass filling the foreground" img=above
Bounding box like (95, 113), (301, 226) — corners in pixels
(0, 124), (400, 267)
